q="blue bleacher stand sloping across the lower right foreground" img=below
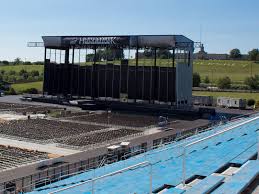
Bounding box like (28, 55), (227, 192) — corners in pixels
(28, 114), (259, 194)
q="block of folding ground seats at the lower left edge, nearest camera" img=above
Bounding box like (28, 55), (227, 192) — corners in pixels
(0, 145), (49, 170)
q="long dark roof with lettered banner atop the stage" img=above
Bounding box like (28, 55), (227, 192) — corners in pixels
(42, 35), (194, 51)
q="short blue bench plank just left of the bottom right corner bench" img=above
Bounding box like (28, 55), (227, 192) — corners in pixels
(185, 175), (224, 194)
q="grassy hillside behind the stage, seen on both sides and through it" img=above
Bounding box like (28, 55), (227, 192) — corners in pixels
(0, 59), (259, 84)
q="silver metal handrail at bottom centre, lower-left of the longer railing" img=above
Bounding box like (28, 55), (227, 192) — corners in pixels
(49, 161), (152, 194)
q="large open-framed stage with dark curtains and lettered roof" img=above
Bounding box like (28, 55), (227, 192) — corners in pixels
(43, 35), (194, 106)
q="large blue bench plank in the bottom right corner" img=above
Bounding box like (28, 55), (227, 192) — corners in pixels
(212, 160), (259, 194)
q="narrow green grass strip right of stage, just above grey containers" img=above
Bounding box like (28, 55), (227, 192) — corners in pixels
(192, 91), (259, 101)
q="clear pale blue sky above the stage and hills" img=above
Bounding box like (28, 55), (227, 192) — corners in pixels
(0, 0), (259, 61)
